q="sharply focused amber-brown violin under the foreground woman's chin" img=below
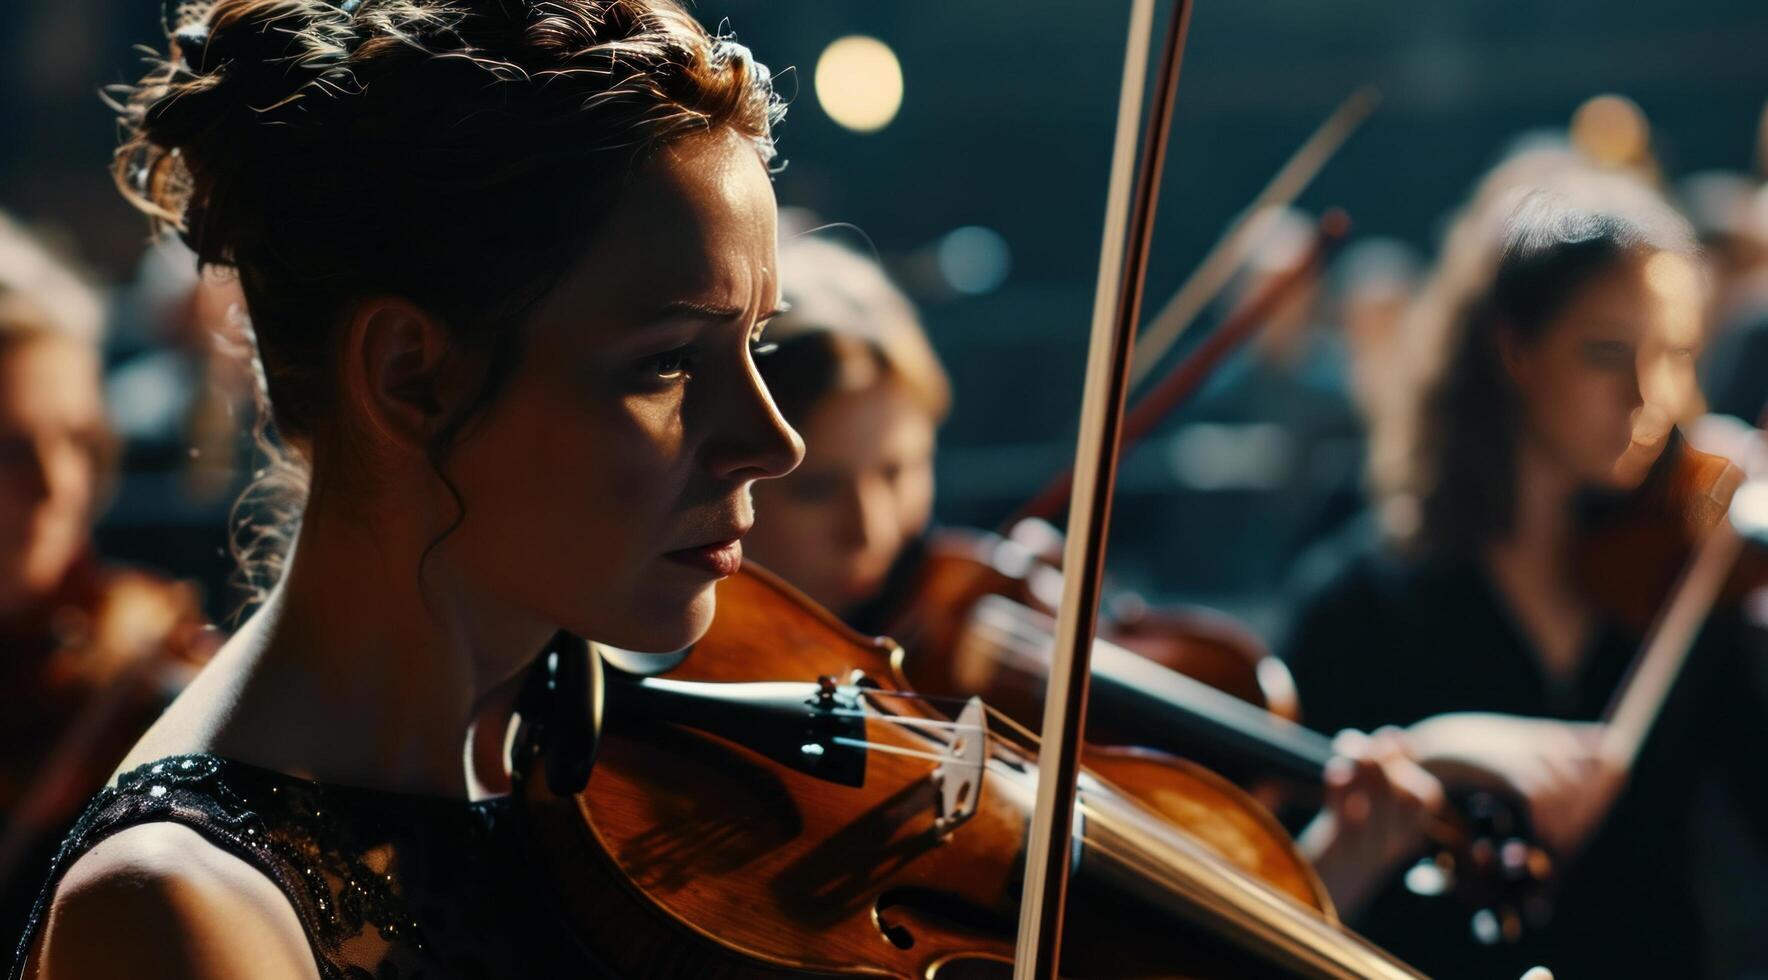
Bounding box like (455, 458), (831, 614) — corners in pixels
(516, 568), (1418, 980)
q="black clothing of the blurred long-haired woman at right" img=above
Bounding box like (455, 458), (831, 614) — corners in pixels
(1282, 541), (1768, 978)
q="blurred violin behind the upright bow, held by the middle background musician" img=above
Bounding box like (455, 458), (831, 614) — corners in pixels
(884, 536), (1554, 943)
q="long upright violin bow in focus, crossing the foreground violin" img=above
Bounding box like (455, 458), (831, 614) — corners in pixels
(1013, 0), (1192, 980)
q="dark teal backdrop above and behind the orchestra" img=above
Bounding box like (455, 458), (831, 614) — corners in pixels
(0, 0), (1768, 626)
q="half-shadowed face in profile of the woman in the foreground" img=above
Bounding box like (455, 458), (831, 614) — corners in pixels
(435, 133), (803, 651)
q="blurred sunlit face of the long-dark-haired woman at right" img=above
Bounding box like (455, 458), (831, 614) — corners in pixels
(1506, 253), (1704, 488)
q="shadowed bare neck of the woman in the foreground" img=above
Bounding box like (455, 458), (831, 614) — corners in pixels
(183, 495), (550, 796)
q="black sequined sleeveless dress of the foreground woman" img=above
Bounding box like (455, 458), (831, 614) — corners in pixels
(9, 755), (606, 980)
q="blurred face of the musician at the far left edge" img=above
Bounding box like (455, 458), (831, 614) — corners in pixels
(0, 338), (110, 616)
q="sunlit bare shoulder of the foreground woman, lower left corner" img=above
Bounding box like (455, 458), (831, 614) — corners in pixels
(27, 823), (318, 980)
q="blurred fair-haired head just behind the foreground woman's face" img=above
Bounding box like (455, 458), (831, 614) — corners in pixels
(746, 234), (951, 633)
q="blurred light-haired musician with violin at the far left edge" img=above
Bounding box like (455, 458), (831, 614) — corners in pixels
(0, 218), (216, 948)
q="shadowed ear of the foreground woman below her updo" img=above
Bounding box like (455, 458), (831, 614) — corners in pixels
(343, 297), (461, 453)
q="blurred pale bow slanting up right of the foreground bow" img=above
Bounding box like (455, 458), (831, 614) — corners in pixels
(1130, 85), (1381, 387)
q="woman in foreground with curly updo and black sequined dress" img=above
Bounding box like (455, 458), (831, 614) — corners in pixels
(19, 0), (801, 980)
